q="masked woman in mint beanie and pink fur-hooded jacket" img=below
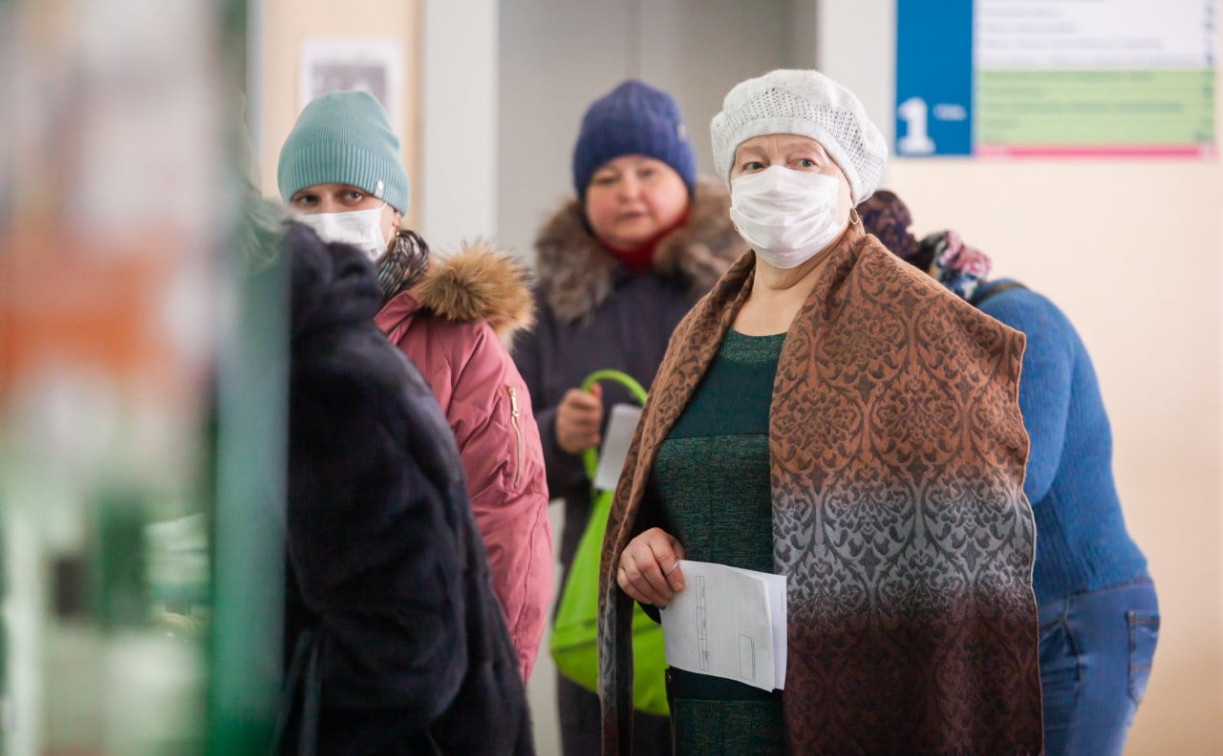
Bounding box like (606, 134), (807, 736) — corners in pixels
(276, 92), (552, 681)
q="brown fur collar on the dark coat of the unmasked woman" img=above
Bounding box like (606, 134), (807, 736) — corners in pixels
(536, 176), (747, 323)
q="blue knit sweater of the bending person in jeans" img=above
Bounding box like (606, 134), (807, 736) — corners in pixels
(981, 281), (1146, 603)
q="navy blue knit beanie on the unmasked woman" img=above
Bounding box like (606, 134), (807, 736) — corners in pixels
(574, 78), (696, 198)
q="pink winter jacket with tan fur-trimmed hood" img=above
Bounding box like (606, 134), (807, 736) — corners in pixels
(375, 247), (553, 681)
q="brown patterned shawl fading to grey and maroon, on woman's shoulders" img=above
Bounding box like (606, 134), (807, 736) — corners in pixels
(599, 221), (1042, 756)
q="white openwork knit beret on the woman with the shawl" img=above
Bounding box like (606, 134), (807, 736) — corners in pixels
(709, 70), (888, 203)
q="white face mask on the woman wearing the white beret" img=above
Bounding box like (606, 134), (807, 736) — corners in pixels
(730, 165), (845, 270)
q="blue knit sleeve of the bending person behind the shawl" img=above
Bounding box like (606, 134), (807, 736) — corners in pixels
(981, 290), (1074, 503)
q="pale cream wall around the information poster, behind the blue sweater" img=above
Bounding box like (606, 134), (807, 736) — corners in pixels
(819, 0), (1223, 756)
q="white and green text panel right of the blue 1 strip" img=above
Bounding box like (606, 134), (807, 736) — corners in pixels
(974, 0), (1218, 158)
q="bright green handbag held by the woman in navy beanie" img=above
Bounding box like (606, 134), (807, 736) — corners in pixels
(550, 371), (669, 717)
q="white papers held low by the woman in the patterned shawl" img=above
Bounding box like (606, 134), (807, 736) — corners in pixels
(662, 559), (785, 690)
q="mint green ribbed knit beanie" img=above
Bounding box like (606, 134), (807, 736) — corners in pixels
(276, 92), (407, 213)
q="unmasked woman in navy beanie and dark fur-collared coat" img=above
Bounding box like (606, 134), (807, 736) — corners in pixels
(515, 80), (746, 756)
